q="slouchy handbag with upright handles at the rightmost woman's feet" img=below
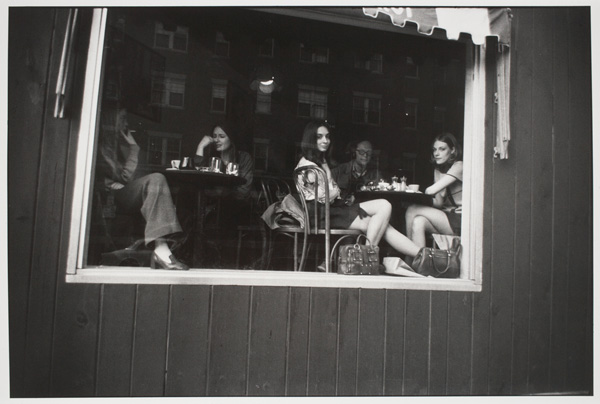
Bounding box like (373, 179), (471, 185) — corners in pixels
(411, 238), (462, 278)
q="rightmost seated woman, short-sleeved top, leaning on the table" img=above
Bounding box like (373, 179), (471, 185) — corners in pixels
(406, 133), (463, 247)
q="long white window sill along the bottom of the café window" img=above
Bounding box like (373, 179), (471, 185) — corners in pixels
(66, 267), (481, 292)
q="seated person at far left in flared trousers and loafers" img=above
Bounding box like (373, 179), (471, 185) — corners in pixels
(97, 108), (189, 270)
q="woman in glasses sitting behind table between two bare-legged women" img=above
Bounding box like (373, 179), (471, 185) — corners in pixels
(331, 140), (381, 204)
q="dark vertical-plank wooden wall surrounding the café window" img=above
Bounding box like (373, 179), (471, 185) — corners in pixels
(8, 8), (592, 397)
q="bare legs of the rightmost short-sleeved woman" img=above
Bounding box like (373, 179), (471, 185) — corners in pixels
(406, 205), (453, 247)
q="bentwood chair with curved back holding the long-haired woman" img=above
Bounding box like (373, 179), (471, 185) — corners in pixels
(294, 166), (362, 272)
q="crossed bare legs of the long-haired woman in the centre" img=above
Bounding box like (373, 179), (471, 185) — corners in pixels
(350, 199), (419, 257)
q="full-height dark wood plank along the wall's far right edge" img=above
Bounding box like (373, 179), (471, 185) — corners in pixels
(566, 7), (592, 391)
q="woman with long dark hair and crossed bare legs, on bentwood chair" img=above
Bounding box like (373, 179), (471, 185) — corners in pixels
(296, 120), (419, 257)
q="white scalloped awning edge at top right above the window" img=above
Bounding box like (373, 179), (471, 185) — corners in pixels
(363, 7), (512, 46)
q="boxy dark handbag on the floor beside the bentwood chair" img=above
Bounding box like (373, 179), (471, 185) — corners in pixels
(337, 234), (381, 275)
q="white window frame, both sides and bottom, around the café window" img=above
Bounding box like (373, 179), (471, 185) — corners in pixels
(66, 8), (486, 292)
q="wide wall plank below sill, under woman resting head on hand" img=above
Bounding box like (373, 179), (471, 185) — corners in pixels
(206, 286), (251, 396)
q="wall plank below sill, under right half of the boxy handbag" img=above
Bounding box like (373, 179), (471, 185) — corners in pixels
(356, 289), (385, 396)
